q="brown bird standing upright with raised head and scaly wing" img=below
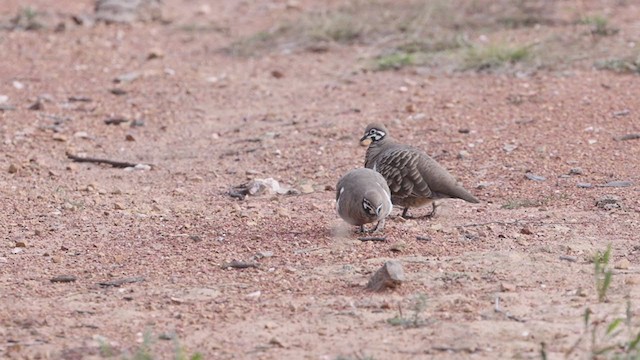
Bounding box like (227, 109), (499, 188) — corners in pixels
(360, 123), (480, 219)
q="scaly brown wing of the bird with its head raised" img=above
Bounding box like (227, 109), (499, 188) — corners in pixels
(375, 148), (431, 198)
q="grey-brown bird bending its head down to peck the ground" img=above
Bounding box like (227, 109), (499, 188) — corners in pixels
(336, 168), (393, 233)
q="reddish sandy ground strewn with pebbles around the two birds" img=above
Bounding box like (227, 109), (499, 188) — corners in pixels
(0, 0), (640, 360)
